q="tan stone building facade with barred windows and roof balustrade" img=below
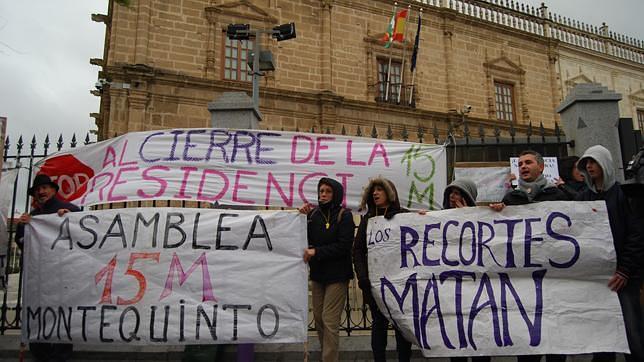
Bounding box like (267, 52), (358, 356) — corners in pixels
(92, 0), (644, 140)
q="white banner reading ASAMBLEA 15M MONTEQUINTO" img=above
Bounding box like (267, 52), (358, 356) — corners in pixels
(22, 208), (308, 345)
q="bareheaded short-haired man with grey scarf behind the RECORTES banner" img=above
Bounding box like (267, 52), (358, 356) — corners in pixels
(490, 150), (568, 362)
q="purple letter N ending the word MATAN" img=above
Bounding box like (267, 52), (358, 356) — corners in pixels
(499, 269), (546, 347)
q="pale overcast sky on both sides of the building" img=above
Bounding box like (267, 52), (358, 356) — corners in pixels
(0, 0), (644, 153)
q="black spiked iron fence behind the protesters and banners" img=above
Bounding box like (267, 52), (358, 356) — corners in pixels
(0, 123), (569, 335)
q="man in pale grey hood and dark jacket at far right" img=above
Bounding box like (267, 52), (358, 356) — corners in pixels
(577, 145), (644, 362)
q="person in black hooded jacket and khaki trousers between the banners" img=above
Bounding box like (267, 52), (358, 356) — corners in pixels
(299, 177), (355, 362)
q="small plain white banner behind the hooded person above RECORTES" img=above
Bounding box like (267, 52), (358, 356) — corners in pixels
(454, 162), (510, 202)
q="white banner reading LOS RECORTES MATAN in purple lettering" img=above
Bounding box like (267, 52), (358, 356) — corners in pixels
(367, 201), (628, 357)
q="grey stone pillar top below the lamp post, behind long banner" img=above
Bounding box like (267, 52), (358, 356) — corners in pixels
(208, 92), (262, 129)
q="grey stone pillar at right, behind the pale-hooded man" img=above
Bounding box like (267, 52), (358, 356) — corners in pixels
(556, 83), (624, 182)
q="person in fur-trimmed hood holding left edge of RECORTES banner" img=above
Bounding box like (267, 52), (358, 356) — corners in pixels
(353, 177), (411, 362)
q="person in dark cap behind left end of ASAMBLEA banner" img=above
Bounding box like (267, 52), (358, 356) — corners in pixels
(16, 174), (80, 362)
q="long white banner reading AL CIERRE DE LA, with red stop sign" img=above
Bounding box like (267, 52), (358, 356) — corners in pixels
(32, 129), (447, 210)
